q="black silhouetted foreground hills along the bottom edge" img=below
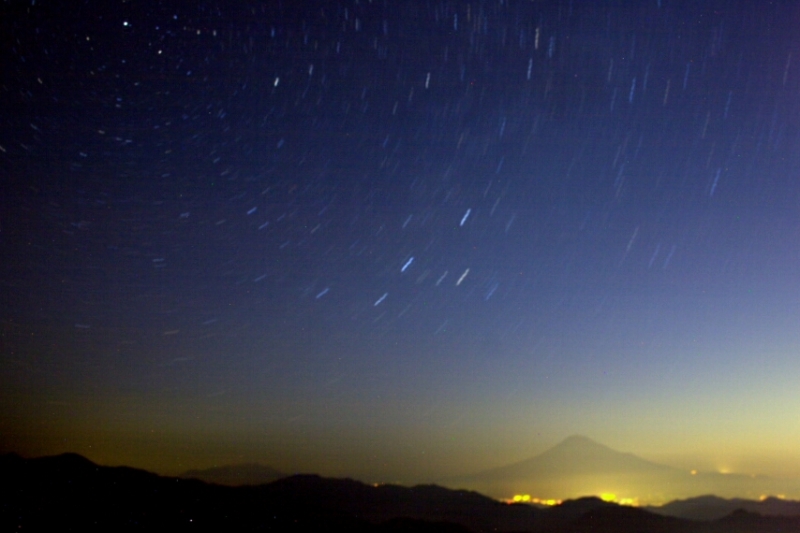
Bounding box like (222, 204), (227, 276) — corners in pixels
(0, 454), (800, 533)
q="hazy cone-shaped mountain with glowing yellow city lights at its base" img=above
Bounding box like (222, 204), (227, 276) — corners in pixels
(440, 436), (800, 504)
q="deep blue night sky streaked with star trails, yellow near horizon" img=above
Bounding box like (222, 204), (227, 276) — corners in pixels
(0, 0), (800, 490)
